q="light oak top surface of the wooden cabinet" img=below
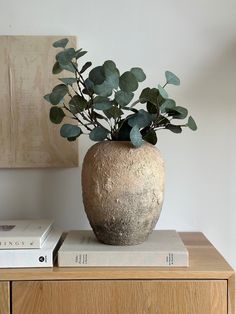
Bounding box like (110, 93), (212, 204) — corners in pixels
(0, 232), (234, 281)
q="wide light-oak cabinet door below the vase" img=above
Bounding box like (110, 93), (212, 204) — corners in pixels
(12, 280), (227, 314)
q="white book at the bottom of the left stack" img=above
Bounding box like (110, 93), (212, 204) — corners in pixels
(0, 229), (62, 268)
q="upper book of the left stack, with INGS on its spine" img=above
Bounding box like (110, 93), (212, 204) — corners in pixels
(0, 219), (53, 250)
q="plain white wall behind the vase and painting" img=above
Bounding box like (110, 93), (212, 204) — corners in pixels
(0, 0), (236, 268)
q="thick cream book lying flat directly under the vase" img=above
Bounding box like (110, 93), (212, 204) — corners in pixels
(58, 230), (189, 267)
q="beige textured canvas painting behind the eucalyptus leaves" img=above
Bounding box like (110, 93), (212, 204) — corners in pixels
(0, 36), (78, 168)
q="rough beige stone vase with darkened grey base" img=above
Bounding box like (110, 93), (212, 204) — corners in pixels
(82, 141), (164, 245)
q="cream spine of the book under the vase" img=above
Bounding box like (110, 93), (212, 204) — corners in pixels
(58, 250), (189, 267)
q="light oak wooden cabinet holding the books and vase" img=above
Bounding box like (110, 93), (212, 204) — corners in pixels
(0, 233), (235, 314)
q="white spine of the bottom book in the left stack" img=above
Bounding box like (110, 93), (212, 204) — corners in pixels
(0, 250), (53, 268)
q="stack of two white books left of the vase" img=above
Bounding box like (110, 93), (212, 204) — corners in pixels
(0, 220), (62, 268)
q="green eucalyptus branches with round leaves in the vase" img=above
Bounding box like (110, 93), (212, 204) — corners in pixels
(44, 38), (197, 147)
